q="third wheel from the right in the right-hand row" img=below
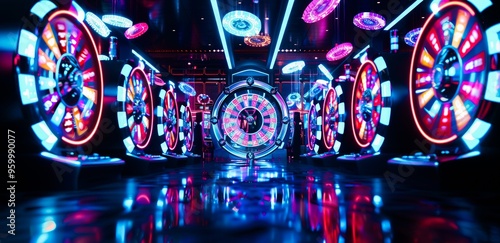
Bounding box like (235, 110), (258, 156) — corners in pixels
(322, 85), (345, 152)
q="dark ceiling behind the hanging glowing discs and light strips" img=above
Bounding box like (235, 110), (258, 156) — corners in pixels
(74, 0), (430, 75)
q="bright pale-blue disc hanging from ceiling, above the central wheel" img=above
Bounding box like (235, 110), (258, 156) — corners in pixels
(222, 10), (262, 37)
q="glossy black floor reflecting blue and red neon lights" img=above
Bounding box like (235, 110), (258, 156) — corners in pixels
(5, 154), (500, 242)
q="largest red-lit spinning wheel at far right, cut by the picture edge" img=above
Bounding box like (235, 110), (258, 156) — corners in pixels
(409, 2), (500, 149)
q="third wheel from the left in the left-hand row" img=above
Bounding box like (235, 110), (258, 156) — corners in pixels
(157, 89), (179, 153)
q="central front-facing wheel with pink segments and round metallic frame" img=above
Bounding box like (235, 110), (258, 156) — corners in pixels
(211, 77), (290, 158)
